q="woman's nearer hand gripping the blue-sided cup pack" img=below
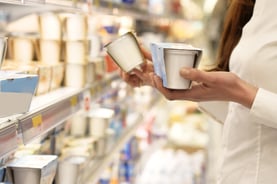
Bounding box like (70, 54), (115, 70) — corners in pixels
(153, 68), (258, 108)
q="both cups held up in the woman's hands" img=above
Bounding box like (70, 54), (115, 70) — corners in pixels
(105, 32), (202, 89)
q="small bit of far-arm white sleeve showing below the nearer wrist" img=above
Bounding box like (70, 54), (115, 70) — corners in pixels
(198, 101), (229, 124)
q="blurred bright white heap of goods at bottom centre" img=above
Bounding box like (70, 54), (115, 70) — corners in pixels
(135, 148), (206, 184)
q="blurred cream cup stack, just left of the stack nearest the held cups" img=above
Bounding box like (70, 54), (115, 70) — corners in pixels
(37, 12), (65, 94)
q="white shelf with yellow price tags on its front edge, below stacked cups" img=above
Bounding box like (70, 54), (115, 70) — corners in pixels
(0, 74), (118, 158)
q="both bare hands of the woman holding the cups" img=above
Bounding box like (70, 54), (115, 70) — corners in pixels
(116, 44), (258, 108)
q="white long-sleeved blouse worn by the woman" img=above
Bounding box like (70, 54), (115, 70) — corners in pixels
(218, 0), (277, 184)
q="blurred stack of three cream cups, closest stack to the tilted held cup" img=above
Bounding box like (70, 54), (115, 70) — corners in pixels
(64, 14), (94, 87)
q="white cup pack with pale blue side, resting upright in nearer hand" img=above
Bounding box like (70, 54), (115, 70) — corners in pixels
(150, 43), (202, 89)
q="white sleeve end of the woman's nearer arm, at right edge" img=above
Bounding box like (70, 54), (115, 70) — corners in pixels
(250, 88), (277, 128)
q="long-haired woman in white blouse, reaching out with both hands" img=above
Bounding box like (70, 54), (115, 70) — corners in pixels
(121, 0), (277, 184)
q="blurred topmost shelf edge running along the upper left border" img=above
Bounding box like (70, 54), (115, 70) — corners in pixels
(0, 0), (184, 20)
